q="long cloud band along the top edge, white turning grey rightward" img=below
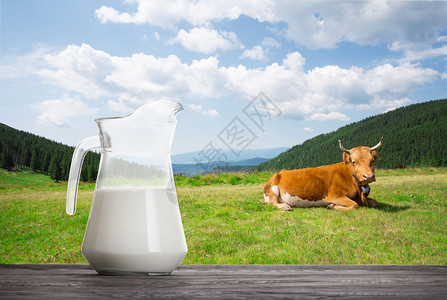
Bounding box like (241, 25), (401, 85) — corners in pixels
(96, 0), (447, 50)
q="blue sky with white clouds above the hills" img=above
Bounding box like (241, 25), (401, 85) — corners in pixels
(0, 0), (447, 154)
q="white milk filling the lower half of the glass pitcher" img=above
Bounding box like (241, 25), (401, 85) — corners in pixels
(82, 188), (188, 274)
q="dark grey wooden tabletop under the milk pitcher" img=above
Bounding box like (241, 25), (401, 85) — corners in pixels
(0, 264), (447, 300)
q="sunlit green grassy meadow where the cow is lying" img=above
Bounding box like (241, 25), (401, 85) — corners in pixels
(0, 168), (447, 265)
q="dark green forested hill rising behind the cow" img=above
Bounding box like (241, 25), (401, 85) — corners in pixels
(253, 99), (447, 171)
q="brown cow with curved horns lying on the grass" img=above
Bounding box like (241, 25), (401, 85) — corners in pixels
(264, 137), (383, 210)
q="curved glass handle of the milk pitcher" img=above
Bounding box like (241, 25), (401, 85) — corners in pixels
(65, 136), (101, 215)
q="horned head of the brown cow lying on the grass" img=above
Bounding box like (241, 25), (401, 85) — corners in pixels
(338, 137), (383, 185)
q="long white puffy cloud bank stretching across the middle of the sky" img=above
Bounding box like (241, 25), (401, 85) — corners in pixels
(22, 44), (442, 123)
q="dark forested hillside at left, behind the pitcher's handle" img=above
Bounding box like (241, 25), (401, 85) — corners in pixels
(0, 123), (100, 181)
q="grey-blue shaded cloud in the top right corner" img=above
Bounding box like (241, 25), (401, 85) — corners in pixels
(274, 1), (447, 49)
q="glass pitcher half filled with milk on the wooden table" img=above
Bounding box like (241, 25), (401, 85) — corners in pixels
(66, 100), (188, 275)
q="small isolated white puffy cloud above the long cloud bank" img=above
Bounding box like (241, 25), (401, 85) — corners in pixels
(171, 27), (241, 54)
